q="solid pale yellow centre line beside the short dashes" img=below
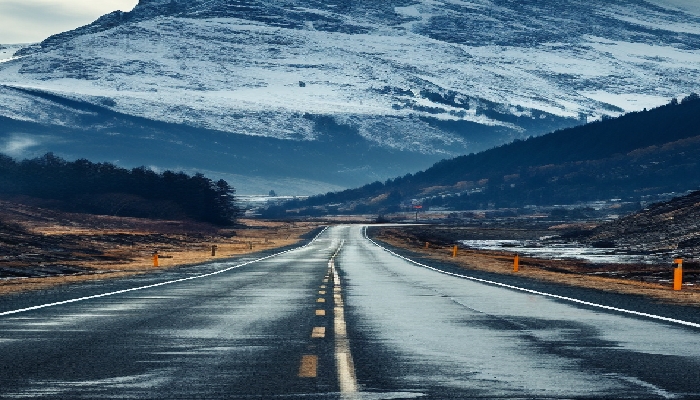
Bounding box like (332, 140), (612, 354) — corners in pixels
(328, 241), (358, 399)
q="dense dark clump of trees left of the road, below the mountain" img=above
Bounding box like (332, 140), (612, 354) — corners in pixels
(0, 153), (239, 226)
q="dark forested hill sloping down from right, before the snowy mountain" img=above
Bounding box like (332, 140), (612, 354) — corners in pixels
(270, 94), (700, 214)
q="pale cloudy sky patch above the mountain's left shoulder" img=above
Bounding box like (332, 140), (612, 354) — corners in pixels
(0, 0), (138, 44)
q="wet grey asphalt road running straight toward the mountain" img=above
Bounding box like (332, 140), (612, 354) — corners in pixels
(0, 226), (700, 400)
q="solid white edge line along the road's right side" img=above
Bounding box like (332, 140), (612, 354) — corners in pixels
(362, 226), (700, 328)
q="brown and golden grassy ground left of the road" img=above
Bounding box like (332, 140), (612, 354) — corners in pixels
(0, 201), (318, 294)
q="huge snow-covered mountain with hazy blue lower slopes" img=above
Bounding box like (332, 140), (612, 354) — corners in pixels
(0, 0), (700, 193)
